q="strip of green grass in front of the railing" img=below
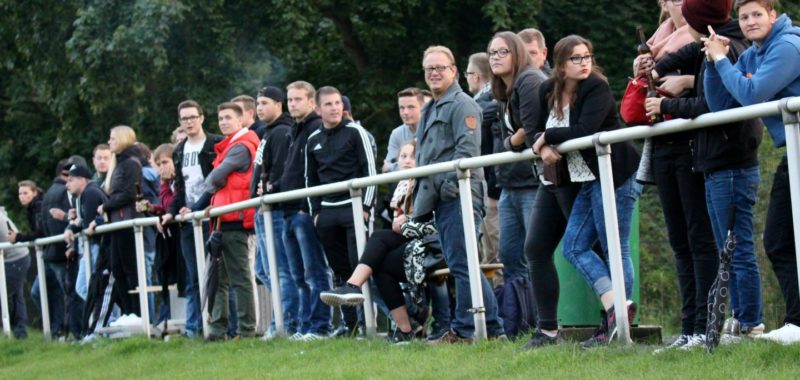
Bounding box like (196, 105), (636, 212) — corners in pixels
(0, 336), (800, 380)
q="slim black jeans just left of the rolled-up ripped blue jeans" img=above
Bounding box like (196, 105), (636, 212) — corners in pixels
(525, 183), (581, 330)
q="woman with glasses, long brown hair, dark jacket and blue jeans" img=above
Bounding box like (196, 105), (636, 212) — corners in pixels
(487, 32), (547, 290)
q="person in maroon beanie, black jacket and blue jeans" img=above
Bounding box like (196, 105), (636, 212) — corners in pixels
(645, 0), (764, 349)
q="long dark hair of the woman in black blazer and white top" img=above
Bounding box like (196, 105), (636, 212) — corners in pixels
(547, 34), (608, 120)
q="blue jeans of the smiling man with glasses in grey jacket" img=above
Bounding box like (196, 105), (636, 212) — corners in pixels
(435, 199), (504, 338)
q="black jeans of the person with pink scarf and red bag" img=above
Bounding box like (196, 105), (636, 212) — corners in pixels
(653, 141), (719, 335)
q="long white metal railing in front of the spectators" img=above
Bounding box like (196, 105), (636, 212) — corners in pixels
(0, 97), (800, 344)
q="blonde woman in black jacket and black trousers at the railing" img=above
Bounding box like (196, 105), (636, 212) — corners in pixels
(97, 126), (142, 316)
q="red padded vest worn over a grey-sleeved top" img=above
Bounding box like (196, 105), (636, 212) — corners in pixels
(211, 131), (259, 229)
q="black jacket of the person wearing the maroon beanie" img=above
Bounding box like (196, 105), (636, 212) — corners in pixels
(655, 20), (764, 172)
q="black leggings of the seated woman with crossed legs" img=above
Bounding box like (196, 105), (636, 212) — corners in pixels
(361, 230), (408, 310)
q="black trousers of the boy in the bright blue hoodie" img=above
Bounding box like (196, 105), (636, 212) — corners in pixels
(764, 156), (800, 326)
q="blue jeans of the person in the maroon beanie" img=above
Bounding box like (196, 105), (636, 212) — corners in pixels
(706, 165), (763, 327)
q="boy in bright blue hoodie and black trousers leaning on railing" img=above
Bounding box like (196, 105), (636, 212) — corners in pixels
(705, 0), (800, 344)
